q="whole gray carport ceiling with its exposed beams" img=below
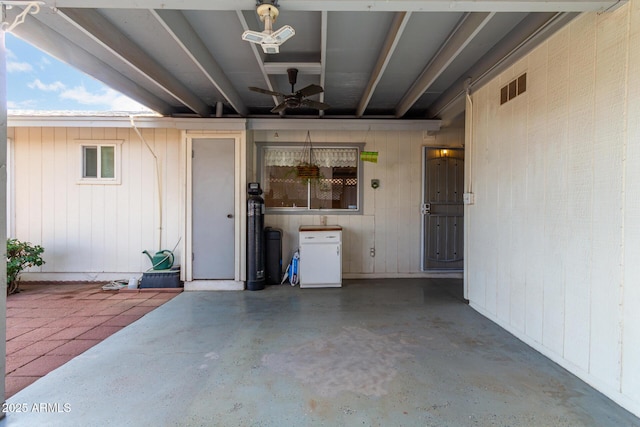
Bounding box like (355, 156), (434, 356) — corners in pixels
(5, 0), (620, 124)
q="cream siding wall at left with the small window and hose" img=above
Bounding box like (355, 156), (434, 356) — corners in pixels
(11, 127), (184, 280)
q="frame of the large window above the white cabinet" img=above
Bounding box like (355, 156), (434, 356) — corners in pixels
(255, 141), (365, 215)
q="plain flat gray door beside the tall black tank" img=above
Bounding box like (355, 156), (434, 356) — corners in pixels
(192, 139), (235, 280)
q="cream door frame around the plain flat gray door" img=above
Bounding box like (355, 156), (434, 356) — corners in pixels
(182, 131), (247, 291)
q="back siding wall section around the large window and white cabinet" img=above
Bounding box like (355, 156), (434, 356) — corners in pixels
(253, 130), (464, 278)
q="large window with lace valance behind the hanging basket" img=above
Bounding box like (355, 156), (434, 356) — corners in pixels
(258, 144), (361, 213)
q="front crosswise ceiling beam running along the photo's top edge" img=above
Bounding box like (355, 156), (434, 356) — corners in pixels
(38, 0), (628, 12)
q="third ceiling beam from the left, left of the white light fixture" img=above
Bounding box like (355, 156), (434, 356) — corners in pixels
(150, 9), (249, 116)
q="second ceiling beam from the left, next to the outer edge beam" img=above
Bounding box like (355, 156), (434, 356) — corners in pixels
(58, 8), (211, 117)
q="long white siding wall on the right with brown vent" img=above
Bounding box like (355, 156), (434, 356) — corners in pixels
(465, 1), (640, 415)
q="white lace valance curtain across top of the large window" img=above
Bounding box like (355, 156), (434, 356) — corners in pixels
(264, 147), (358, 167)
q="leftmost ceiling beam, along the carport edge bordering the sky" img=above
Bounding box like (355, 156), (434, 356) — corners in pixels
(8, 8), (173, 115)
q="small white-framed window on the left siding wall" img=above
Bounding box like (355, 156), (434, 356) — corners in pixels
(81, 141), (120, 184)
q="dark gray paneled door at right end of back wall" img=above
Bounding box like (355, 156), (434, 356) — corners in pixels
(421, 147), (464, 270)
